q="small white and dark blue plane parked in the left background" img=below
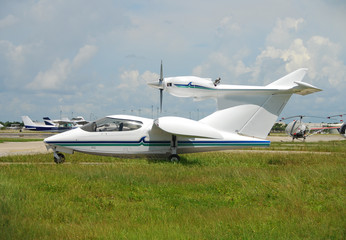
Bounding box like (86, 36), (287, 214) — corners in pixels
(22, 116), (76, 132)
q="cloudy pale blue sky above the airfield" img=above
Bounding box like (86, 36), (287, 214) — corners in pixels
(0, 0), (346, 122)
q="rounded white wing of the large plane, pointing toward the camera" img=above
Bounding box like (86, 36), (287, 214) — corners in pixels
(155, 117), (222, 139)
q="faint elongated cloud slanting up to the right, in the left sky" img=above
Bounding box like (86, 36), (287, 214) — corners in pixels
(27, 45), (97, 90)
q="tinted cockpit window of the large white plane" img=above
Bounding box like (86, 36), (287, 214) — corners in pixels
(81, 117), (143, 132)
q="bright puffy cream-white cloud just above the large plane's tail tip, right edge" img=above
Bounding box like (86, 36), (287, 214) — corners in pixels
(253, 32), (346, 90)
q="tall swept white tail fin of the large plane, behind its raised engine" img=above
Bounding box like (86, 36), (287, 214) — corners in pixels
(200, 69), (321, 138)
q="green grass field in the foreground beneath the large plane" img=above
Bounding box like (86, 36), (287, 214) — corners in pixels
(0, 141), (346, 239)
